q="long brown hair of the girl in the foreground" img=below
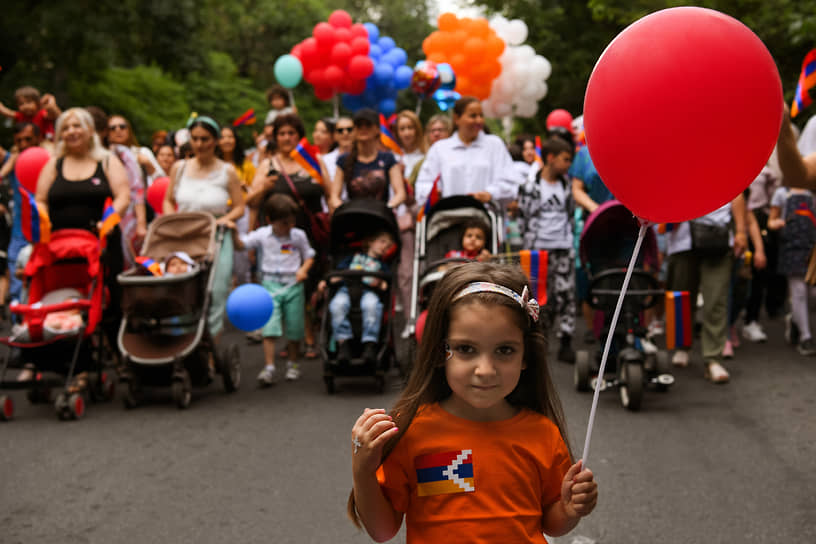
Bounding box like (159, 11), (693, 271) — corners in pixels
(348, 262), (572, 527)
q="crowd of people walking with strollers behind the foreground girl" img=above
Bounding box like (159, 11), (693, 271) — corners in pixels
(0, 82), (816, 392)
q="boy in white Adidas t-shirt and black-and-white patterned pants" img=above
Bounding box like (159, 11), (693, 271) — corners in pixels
(518, 137), (575, 363)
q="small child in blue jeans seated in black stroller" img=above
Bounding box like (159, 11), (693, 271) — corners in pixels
(318, 231), (394, 364)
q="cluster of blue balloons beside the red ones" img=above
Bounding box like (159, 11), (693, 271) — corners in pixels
(343, 23), (413, 115)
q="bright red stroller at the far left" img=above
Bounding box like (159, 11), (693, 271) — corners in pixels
(0, 229), (116, 420)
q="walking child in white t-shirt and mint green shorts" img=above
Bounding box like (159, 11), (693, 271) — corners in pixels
(236, 194), (315, 386)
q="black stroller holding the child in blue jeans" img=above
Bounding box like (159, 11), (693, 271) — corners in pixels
(320, 199), (399, 394)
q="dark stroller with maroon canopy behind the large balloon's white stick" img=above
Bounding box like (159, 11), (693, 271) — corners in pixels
(574, 201), (674, 410)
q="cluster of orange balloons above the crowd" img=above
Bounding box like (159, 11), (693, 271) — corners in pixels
(422, 13), (504, 100)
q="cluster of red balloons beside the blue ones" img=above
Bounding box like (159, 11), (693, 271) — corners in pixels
(292, 10), (374, 100)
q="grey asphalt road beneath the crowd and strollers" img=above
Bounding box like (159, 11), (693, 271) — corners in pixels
(0, 314), (816, 544)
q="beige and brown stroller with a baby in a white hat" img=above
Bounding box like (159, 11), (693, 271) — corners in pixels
(117, 212), (241, 408)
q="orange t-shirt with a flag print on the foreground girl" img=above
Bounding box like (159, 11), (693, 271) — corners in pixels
(377, 404), (571, 544)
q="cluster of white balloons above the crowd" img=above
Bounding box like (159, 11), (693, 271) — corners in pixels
(482, 15), (552, 117)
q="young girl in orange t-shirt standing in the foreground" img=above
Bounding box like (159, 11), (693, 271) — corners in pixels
(348, 263), (598, 544)
